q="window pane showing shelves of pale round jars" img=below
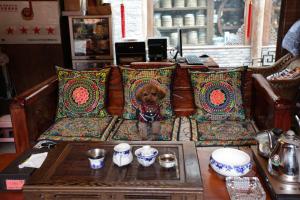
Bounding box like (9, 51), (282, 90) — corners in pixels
(154, 0), (212, 46)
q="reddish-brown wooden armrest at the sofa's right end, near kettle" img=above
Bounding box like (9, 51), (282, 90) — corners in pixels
(251, 74), (292, 130)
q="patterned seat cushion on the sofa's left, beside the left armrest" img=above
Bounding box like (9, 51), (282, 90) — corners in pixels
(39, 117), (117, 141)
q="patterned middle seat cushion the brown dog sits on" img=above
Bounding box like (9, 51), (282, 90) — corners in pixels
(108, 118), (180, 141)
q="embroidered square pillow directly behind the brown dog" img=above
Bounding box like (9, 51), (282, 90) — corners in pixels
(121, 67), (175, 119)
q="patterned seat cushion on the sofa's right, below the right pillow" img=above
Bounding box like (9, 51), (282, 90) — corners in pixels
(191, 119), (257, 146)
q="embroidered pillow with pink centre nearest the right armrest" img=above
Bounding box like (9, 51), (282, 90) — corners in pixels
(189, 68), (245, 121)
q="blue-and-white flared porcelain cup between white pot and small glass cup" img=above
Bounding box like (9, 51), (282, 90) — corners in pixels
(134, 145), (158, 167)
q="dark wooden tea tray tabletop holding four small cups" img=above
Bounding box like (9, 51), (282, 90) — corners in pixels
(23, 142), (203, 192)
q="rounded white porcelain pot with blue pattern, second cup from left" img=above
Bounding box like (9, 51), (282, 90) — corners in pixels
(113, 143), (133, 167)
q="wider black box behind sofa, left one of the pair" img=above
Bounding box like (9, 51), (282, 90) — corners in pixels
(115, 42), (146, 65)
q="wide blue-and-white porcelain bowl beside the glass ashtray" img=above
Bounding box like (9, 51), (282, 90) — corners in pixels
(210, 148), (251, 176)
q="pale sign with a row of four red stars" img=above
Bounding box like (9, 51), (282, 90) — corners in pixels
(0, 0), (61, 44)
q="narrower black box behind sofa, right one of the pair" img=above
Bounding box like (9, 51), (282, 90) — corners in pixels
(148, 38), (167, 61)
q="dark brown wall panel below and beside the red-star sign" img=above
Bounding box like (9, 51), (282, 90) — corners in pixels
(0, 0), (71, 94)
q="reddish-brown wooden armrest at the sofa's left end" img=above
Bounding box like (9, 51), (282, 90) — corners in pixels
(10, 76), (58, 152)
